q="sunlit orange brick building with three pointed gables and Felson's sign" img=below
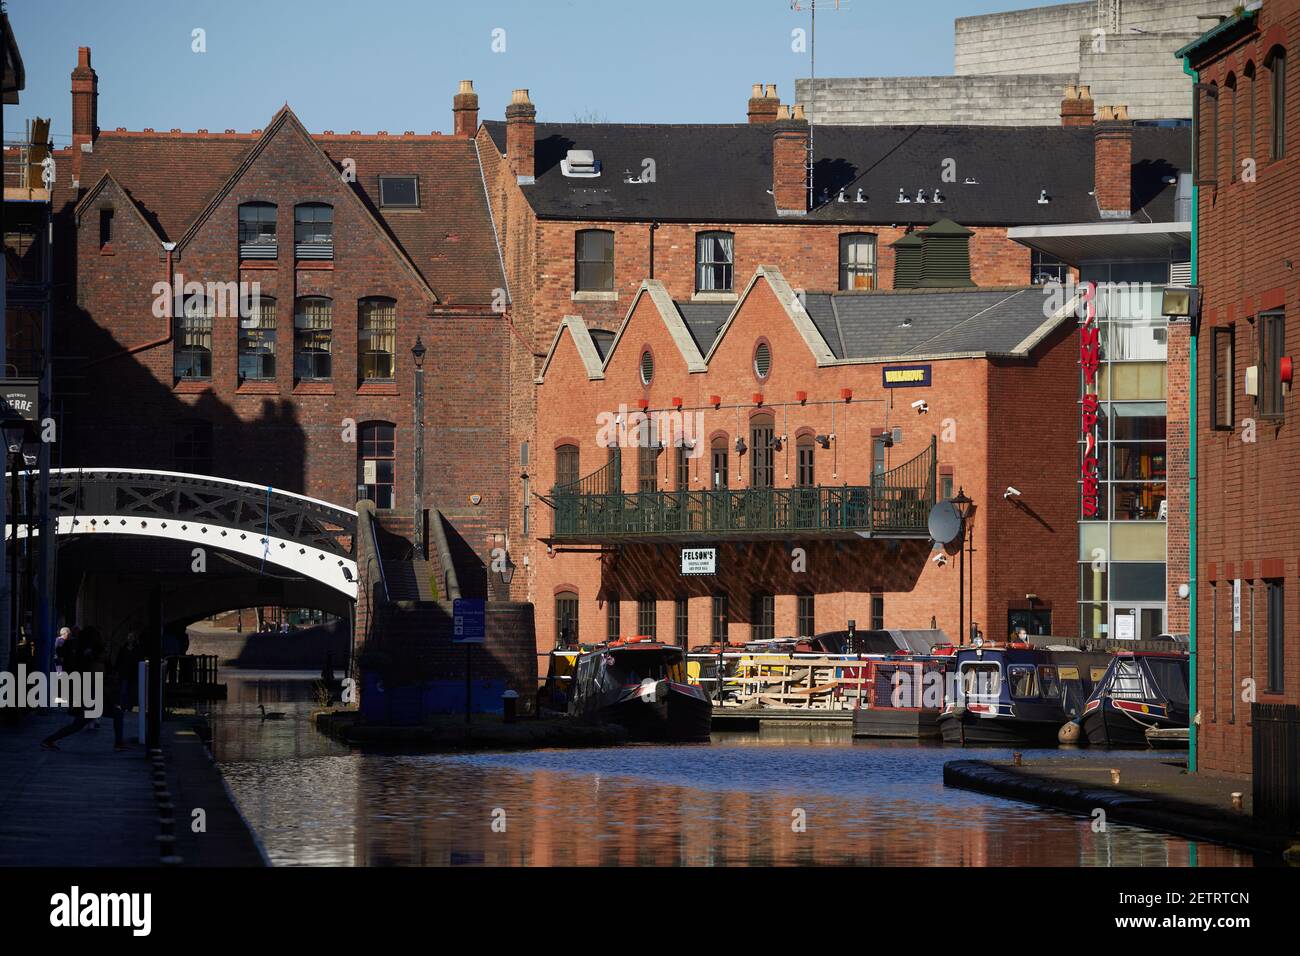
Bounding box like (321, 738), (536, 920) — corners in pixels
(529, 265), (1078, 652)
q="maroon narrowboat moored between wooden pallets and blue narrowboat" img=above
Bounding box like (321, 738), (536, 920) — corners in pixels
(853, 654), (953, 740)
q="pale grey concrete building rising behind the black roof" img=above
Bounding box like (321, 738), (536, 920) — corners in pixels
(796, 0), (1232, 126)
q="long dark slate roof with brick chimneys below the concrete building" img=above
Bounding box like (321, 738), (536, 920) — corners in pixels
(484, 121), (1191, 226)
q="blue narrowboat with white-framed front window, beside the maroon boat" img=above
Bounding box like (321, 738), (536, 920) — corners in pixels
(939, 643), (1106, 747)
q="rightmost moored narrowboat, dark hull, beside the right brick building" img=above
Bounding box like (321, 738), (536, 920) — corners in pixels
(1083, 650), (1190, 747)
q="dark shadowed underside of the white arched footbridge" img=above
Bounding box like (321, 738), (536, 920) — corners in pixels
(57, 533), (351, 643)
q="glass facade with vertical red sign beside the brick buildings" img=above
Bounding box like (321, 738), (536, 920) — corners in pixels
(1079, 269), (1169, 640)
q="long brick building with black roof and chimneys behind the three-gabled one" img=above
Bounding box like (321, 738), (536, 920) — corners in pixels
(475, 86), (1188, 616)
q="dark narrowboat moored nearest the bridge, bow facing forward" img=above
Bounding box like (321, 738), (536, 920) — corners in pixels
(569, 637), (714, 741)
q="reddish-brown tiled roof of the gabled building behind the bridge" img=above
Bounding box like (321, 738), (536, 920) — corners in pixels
(71, 111), (506, 306)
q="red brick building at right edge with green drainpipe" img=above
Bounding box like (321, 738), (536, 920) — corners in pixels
(1182, 0), (1300, 773)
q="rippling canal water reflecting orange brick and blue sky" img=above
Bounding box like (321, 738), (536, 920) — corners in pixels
(209, 671), (1251, 866)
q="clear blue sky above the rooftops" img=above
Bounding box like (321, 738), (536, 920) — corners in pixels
(5, 0), (1043, 144)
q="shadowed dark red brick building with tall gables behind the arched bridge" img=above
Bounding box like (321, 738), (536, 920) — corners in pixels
(47, 48), (510, 591)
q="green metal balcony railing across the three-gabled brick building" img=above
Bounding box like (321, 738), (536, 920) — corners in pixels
(547, 438), (935, 538)
